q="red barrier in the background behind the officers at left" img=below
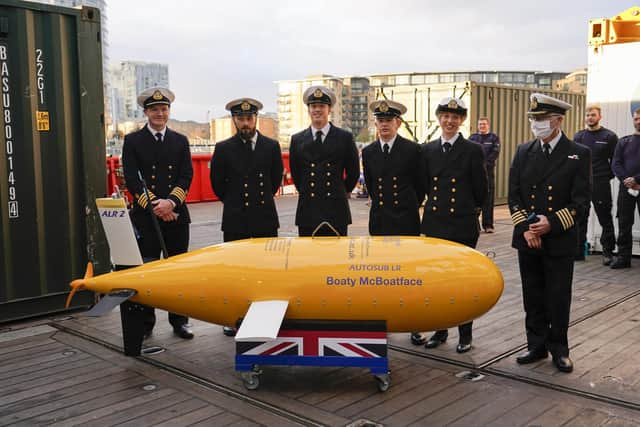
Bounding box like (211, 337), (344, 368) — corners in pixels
(107, 152), (293, 203)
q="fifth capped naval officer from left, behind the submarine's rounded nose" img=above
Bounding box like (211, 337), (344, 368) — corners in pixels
(411, 97), (488, 353)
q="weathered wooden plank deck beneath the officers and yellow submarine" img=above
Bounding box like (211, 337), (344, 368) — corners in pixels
(0, 197), (640, 426)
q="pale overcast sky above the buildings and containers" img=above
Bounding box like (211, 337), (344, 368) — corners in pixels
(107, 0), (634, 121)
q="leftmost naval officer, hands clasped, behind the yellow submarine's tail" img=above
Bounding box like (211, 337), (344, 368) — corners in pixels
(122, 87), (193, 339)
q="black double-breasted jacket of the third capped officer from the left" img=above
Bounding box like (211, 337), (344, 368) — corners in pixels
(289, 124), (360, 231)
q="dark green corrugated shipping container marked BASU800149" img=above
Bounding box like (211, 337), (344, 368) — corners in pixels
(0, 0), (110, 322)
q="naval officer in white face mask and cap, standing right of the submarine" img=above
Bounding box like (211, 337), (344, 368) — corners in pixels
(509, 93), (591, 372)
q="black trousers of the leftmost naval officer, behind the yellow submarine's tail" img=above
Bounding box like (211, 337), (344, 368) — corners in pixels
(137, 219), (189, 333)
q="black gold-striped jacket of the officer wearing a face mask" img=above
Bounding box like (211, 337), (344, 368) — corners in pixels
(509, 134), (591, 257)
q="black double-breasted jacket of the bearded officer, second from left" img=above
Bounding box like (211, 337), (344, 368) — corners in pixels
(210, 132), (283, 235)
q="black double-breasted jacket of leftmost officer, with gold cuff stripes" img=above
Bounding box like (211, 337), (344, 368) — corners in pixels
(122, 125), (193, 227)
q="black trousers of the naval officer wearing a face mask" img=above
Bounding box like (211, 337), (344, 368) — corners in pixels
(518, 251), (573, 357)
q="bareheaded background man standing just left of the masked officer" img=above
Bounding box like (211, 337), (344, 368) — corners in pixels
(469, 117), (500, 233)
